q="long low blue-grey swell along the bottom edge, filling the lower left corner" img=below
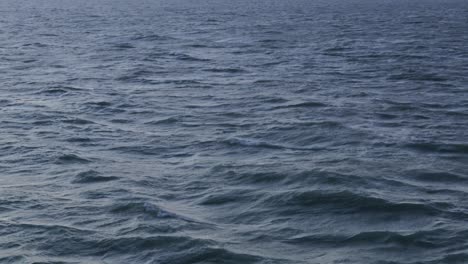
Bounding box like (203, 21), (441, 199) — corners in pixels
(2, 223), (263, 264)
